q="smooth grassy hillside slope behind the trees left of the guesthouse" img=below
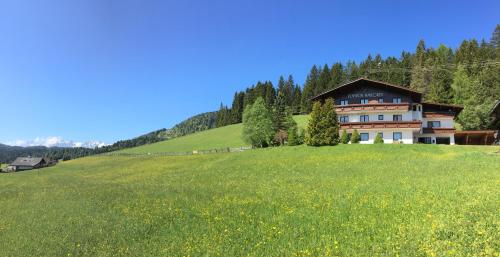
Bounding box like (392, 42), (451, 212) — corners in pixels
(120, 115), (309, 154)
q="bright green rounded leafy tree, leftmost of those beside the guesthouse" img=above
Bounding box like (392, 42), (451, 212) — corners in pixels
(242, 97), (274, 147)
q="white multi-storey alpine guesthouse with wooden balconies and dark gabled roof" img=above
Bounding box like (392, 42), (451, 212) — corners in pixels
(312, 78), (462, 144)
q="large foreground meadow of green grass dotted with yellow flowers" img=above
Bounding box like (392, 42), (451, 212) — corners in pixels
(0, 143), (500, 256)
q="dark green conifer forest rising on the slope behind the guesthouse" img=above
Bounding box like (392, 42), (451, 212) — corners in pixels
(216, 25), (500, 130)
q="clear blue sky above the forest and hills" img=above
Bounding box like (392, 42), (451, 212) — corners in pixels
(0, 0), (500, 143)
